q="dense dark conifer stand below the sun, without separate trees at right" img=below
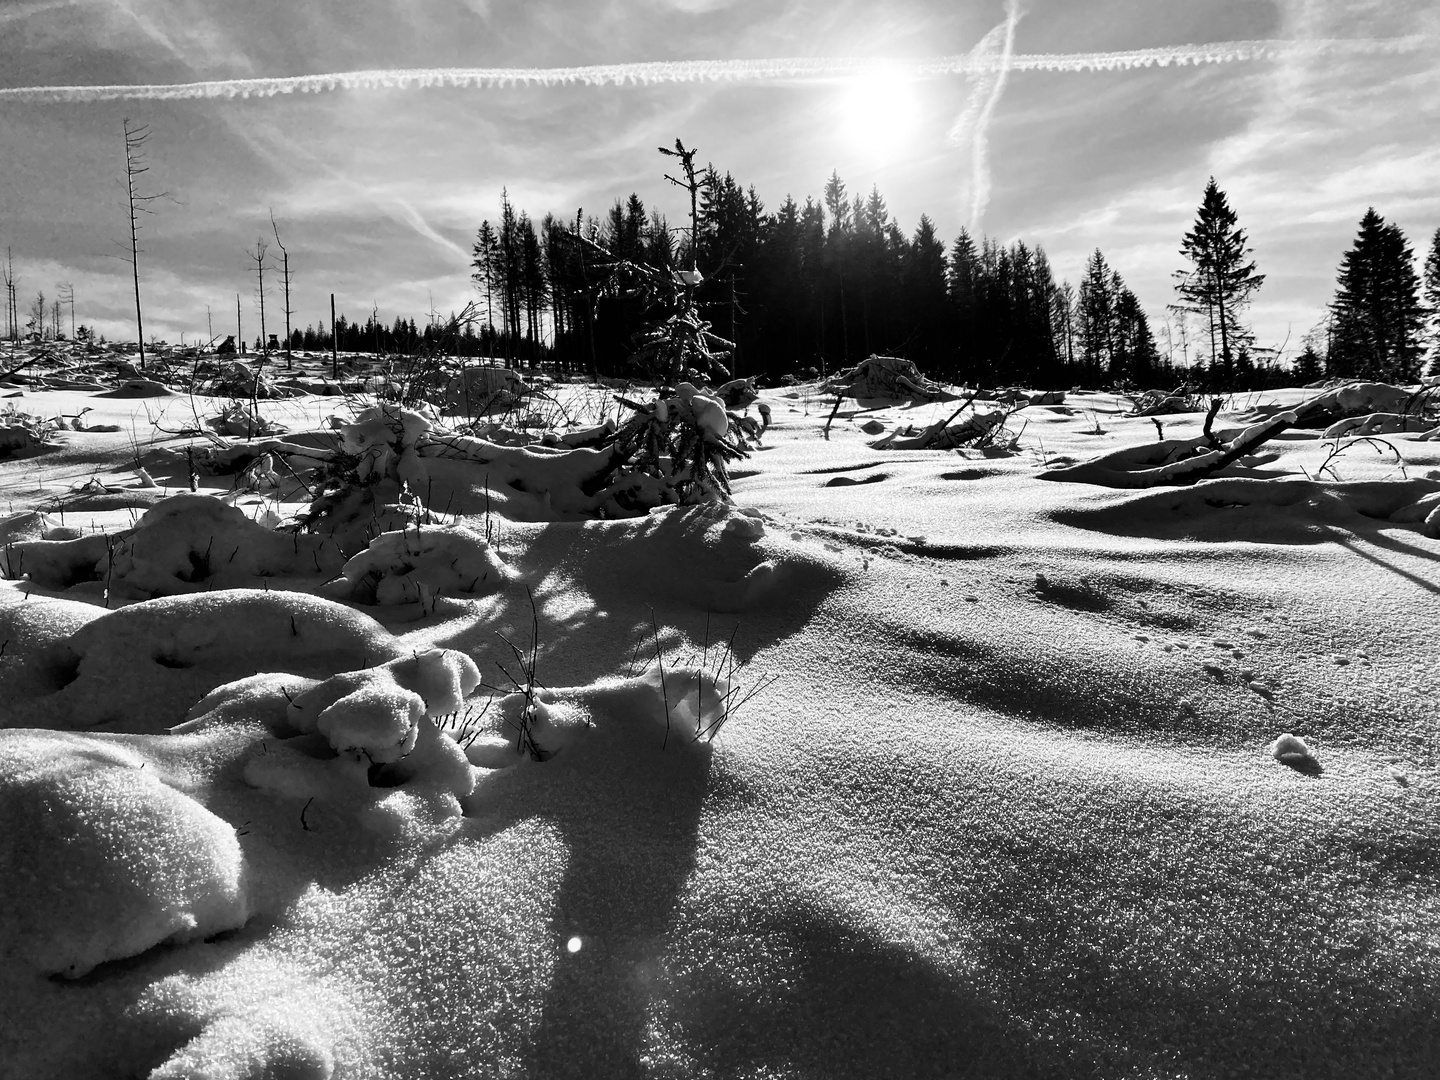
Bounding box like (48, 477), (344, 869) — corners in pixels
(471, 175), (1188, 386)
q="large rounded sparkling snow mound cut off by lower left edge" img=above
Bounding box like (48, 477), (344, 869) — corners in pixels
(0, 730), (249, 978)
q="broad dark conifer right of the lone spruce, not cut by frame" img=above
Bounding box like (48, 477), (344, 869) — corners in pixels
(1326, 207), (1424, 383)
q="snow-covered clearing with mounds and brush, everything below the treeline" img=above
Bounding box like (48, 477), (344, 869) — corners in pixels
(0, 344), (1440, 1080)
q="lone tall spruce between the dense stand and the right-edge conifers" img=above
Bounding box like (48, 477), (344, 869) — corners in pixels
(1175, 177), (1264, 379)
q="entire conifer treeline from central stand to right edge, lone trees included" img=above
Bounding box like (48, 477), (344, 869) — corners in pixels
(471, 167), (1440, 392)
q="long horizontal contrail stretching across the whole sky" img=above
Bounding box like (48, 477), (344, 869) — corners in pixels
(0, 35), (1434, 104)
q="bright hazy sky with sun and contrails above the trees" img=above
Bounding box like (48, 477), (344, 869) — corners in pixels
(0, 0), (1440, 365)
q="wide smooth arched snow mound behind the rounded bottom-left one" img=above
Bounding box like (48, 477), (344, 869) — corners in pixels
(36, 589), (403, 732)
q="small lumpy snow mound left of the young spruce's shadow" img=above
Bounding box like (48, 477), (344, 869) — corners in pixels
(324, 524), (507, 605)
